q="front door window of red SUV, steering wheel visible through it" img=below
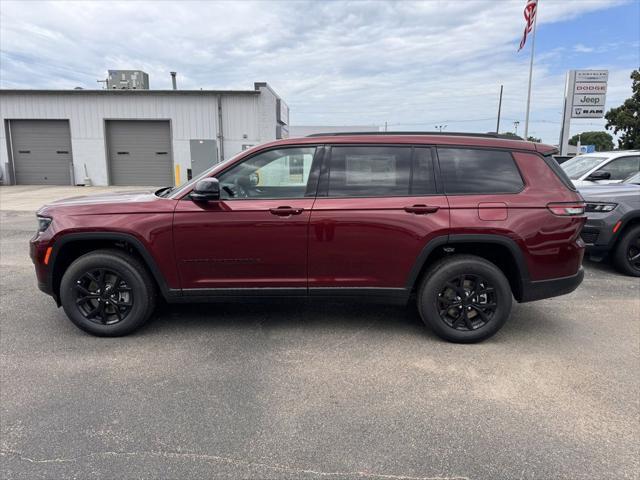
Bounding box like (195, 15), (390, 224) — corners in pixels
(218, 147), (316, 199)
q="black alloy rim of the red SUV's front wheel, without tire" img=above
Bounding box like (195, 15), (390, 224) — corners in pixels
(74, 268), (133, 325)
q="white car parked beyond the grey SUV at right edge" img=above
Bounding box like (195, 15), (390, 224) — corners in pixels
(560, 150), (640, 188)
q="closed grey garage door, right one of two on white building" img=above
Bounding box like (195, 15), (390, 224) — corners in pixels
(107, 120), (173, 186)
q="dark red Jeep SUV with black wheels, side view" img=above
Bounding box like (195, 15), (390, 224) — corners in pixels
(31, 133), (585, 342)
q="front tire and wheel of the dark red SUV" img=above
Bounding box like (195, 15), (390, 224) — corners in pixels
(60, 250), (156, 337)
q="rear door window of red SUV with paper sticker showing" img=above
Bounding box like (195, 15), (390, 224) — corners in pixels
(328, 146), (411, 197)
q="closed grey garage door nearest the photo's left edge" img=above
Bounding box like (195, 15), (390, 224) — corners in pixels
(9, 120), (72, 185)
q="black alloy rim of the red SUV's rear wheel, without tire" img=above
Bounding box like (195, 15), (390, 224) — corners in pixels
(436, 274), (497, 331)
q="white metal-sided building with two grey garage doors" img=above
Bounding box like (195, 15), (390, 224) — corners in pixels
(0, 83), (289, 186)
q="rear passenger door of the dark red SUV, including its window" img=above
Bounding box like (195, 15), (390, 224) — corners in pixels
(309, 145), (449, 295)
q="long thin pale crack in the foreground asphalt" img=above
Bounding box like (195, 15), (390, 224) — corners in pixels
(0, 450), (469, 480)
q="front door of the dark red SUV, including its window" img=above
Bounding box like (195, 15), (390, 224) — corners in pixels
(174, 146), (317, 295)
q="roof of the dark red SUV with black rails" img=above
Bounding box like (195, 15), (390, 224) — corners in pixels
(261, 132), (557, 155)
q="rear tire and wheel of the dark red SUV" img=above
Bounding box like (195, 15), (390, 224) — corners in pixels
(418, 255), (512, 343)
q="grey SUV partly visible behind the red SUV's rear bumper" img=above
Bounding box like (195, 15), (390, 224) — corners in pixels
(580, 173), (640, 277)
